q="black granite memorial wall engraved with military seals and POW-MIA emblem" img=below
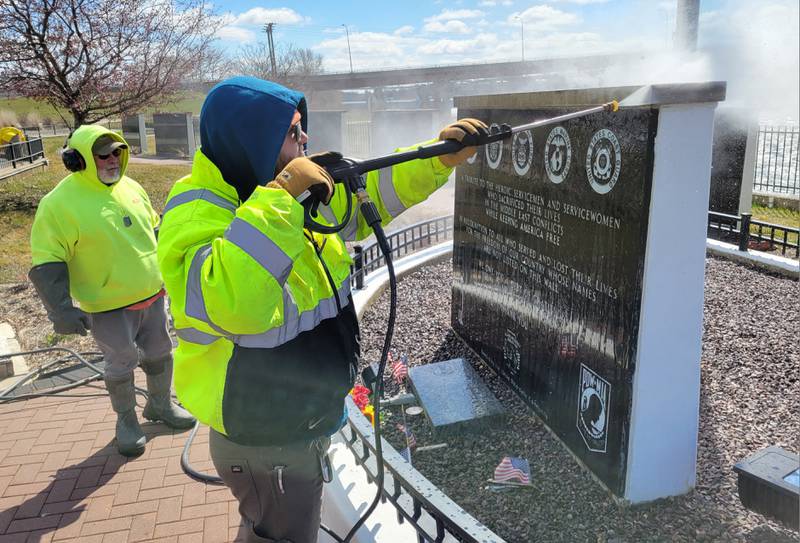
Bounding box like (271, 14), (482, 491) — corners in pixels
(452, 101), (660, 495)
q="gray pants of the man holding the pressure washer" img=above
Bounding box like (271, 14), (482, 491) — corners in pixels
(209, 429), (330, 543)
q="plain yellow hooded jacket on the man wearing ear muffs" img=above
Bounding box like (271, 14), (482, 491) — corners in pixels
(31, 125), (162, 313)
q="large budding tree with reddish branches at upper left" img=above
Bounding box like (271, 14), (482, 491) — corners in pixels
(0, 0), (220, 126)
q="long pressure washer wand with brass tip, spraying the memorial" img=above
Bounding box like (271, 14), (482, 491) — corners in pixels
(325, 100), (619, 182)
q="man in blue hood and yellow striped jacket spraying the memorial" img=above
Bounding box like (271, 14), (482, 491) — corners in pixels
(158, 77), (486, 543)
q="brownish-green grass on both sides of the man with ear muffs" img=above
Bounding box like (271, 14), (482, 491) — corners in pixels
(0, 151), (191, 283)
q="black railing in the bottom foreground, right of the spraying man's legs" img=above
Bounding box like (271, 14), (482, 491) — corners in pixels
(339, 398), (503, 543)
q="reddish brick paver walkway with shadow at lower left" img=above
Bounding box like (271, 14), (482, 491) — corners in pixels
(0, 371), (240, 543)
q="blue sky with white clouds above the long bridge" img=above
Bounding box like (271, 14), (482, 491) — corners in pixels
(208, 0), (797, 71)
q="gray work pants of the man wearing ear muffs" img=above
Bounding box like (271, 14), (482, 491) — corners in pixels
(91, 296), (172, 380)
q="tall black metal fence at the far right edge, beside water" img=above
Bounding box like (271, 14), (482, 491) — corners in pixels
(753, 124), (800, 196)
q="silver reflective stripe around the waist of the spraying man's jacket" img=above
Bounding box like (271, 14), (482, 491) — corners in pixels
(176, 278), (350, 349)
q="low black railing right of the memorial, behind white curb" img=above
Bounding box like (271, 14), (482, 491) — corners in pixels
(708, 211), (800, 258)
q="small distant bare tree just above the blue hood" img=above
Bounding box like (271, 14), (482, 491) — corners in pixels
(232, 43), (323, 87)
